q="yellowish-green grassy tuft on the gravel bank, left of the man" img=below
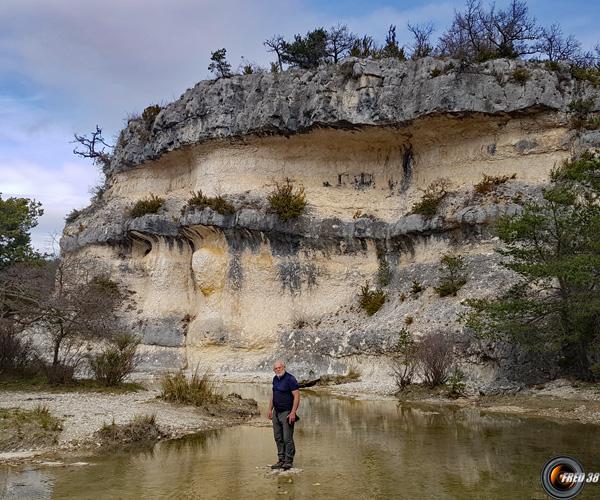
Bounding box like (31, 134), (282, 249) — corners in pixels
(160, 368), (223, 406)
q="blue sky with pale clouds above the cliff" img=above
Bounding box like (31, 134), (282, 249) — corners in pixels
(0, 0), (600, 251)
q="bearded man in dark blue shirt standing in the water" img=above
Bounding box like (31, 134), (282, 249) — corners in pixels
(268, 361), (300, 470)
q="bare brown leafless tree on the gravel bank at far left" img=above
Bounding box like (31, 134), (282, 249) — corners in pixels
(0, 256), (126, 382)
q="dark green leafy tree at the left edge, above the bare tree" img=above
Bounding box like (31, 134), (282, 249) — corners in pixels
(0, 193), (44, 270)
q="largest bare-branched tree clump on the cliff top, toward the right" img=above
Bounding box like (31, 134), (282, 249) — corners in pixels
(439, 0), (540, 61)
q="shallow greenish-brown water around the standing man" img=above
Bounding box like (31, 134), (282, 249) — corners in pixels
(0, 385), (600, 499)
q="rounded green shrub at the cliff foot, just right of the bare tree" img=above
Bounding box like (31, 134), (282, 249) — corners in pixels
(89, 334), (140, 387)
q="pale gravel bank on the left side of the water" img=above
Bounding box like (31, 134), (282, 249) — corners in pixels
(0, 389), (258, 463)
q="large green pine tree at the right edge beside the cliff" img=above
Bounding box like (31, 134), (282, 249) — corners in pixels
(465, 154), (600, 380)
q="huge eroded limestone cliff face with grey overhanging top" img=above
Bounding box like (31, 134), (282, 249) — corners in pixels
(61, 58), (600, 390)
